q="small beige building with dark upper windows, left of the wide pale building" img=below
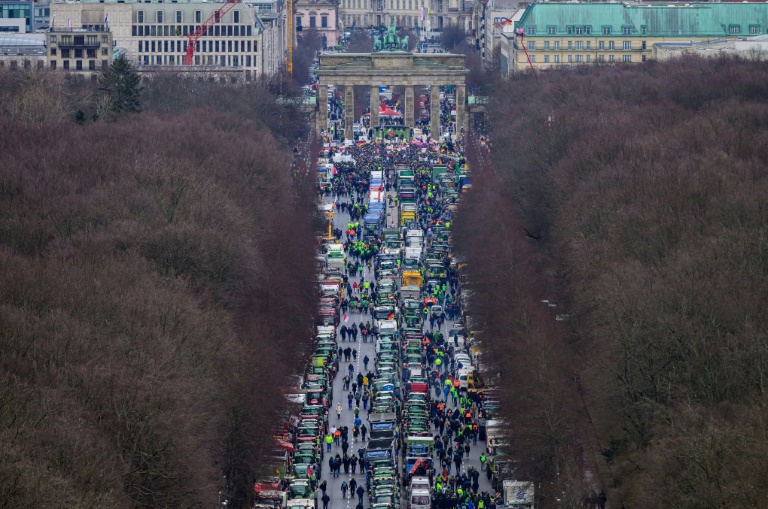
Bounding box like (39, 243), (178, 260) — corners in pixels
(45, 27), (113, 76)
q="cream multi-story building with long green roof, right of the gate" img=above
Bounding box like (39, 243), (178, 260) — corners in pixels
(501, 3), (768, 74)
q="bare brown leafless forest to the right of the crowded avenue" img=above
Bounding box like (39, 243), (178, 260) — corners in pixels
(456, 58), (768, 509)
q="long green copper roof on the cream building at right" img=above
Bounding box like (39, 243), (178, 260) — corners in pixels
(515, 3), (768, 37)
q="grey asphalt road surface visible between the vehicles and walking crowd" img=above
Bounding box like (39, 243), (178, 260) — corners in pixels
(320, 183), (491, 509)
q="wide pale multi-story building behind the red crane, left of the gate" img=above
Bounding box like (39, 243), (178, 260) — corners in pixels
(51, 0), (281, 78)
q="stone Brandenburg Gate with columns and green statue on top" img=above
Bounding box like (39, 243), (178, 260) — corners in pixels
(317, 27), (469, 140)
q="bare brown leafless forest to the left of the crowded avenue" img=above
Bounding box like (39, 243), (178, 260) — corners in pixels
(0, 71), (317, 508)
